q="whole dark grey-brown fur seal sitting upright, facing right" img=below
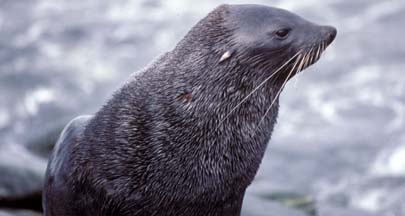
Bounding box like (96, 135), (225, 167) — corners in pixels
(43, 5), (336, 216)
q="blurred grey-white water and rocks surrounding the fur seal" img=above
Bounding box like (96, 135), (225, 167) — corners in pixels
(0, 0), (405, 216)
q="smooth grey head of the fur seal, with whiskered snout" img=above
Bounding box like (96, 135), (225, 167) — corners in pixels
(224, 5), (337, 80)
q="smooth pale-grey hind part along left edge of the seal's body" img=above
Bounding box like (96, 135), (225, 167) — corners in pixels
(42, 116), (93, 215)
